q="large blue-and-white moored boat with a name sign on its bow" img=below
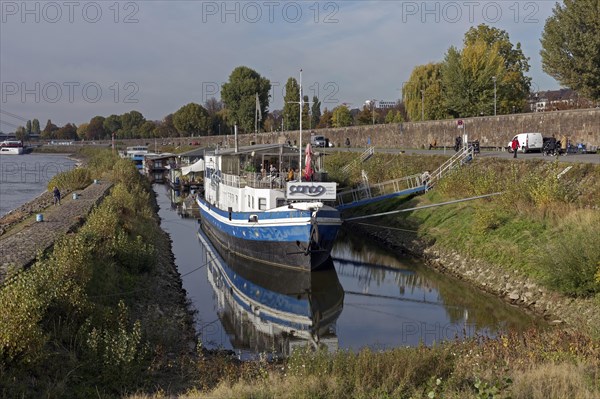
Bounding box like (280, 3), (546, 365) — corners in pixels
(197, 144), (342, 271)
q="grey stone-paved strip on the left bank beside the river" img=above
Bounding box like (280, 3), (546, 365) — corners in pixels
(0, 182), (112, 284)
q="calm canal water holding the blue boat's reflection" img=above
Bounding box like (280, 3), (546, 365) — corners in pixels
(154, 185), (541, 358)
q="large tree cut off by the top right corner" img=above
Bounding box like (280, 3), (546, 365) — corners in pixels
(540, 0), (600, 100)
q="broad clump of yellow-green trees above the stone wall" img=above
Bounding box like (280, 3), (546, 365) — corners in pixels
(402, 24), (531, 120)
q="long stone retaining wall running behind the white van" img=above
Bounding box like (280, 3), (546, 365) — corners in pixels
(128, 108), (600, 148)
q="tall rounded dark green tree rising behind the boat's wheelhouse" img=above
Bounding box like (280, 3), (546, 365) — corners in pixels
(221, 66), (271, 132)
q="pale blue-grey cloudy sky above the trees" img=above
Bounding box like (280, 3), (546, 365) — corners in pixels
(0, 0), (559, 132)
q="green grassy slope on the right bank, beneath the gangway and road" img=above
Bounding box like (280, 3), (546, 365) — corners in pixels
(330, 154), (600, 299)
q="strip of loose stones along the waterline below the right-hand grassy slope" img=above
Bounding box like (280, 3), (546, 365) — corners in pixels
(351, 223), (600, 331)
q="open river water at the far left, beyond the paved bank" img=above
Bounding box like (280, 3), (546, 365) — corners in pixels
(0, 154), (75, 217)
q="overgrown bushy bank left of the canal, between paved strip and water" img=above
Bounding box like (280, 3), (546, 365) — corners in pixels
(0, 150), (196, 398)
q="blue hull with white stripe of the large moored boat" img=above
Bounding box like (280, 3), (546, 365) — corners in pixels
(198, 199), (341, 271)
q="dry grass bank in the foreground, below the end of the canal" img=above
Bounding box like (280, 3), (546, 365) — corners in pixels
(129, 330), (600, 399)
